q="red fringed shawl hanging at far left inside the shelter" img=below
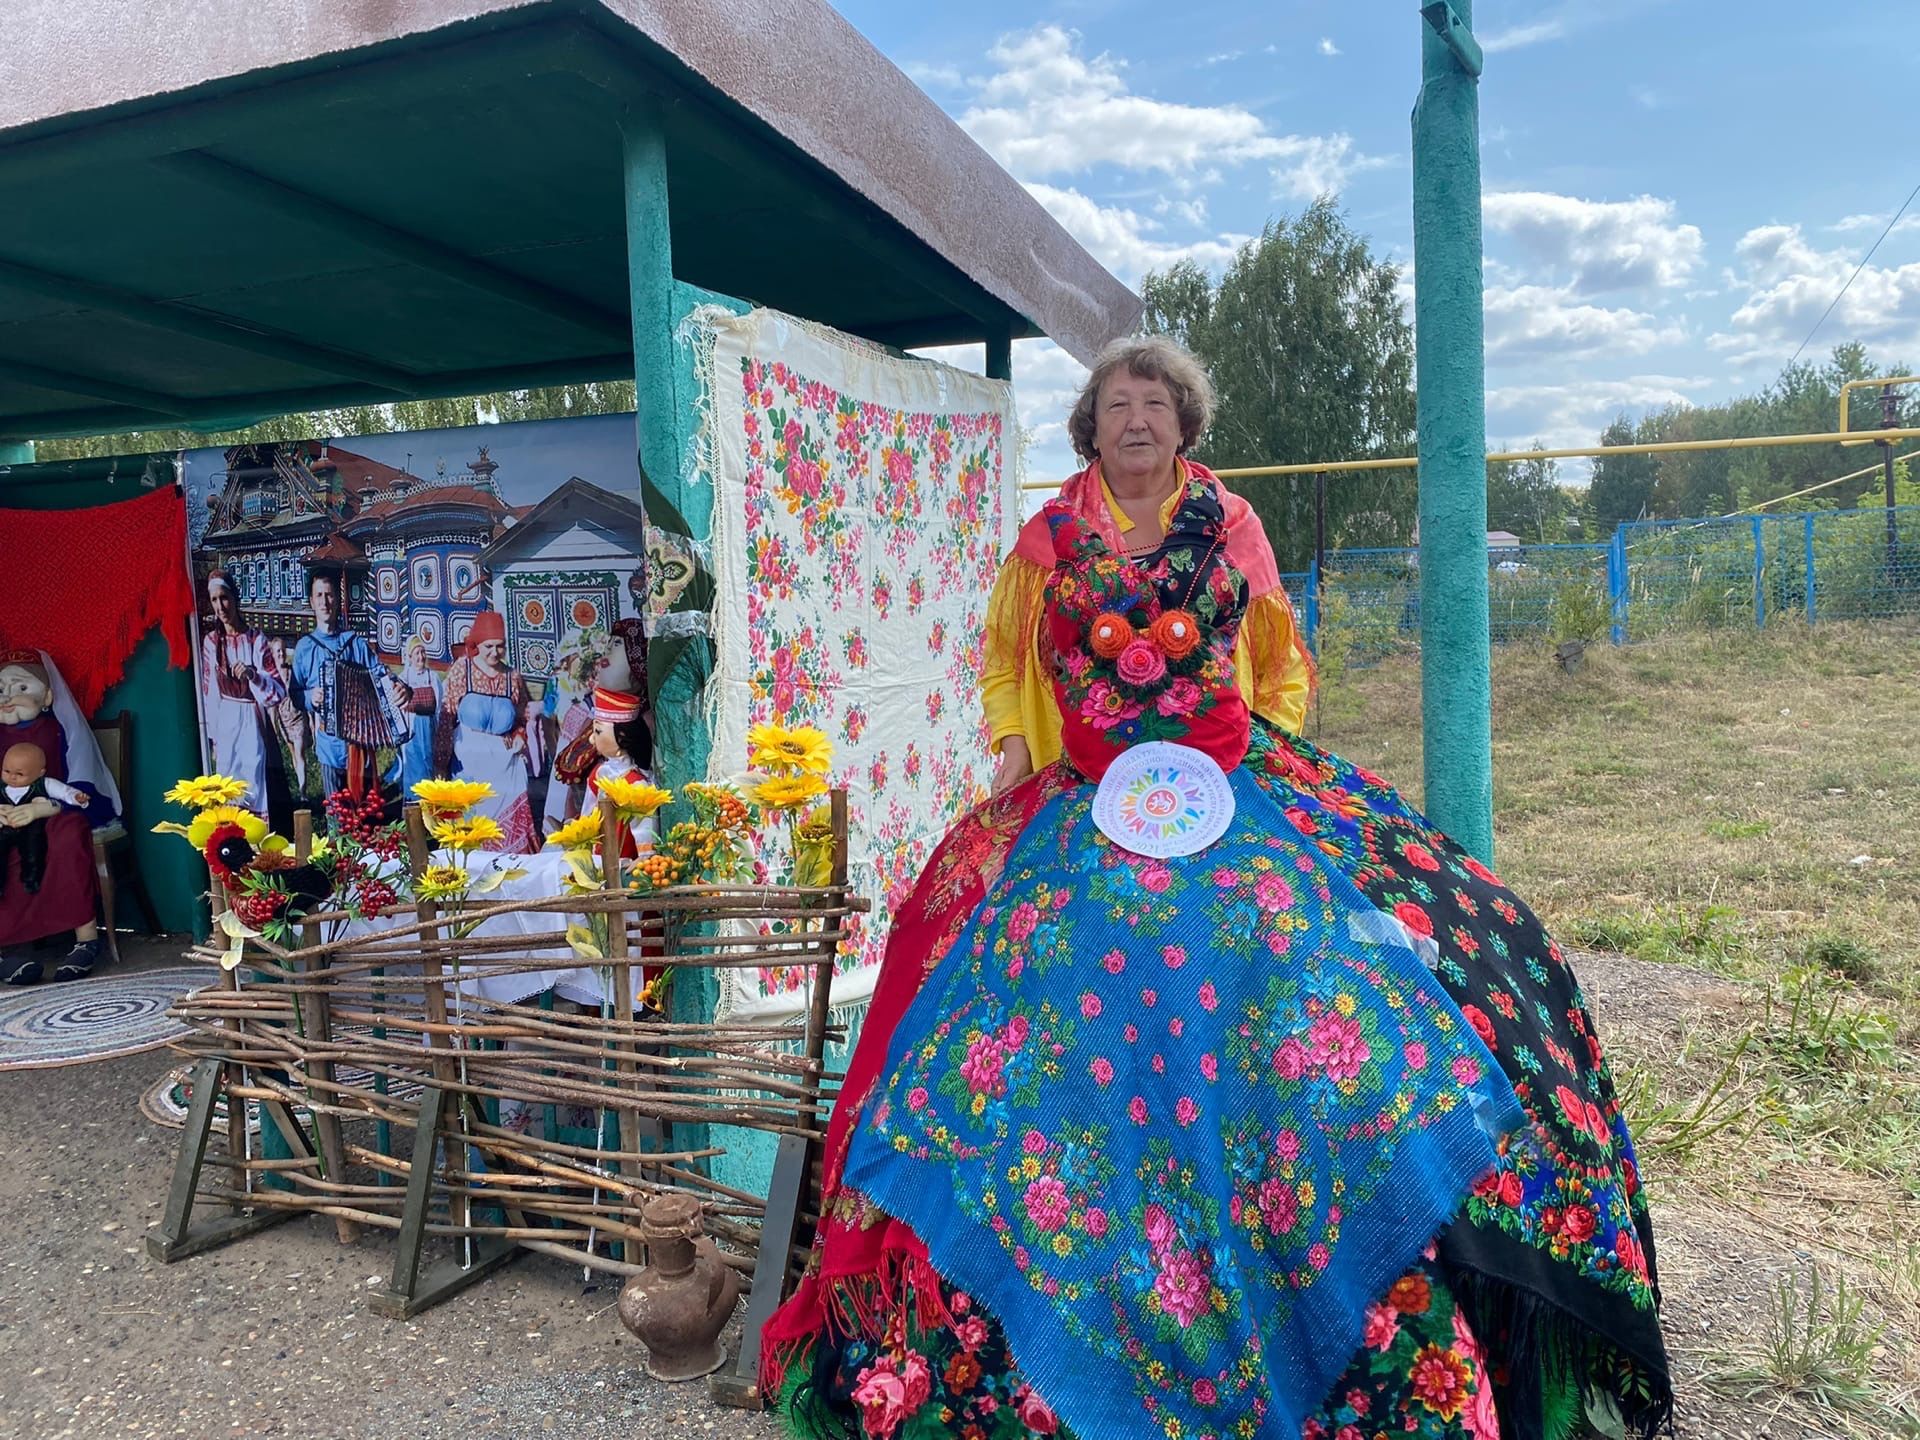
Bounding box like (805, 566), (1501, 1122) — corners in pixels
(0, 486), (194, 716)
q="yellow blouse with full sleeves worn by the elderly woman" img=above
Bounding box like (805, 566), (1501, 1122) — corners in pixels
(981, 480), (1313, 770)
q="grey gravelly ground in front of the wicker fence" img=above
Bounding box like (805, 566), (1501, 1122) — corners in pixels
(0, 945), (781, 1440)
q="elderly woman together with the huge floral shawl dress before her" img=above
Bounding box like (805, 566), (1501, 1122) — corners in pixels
(762, 340), (1672, 1440)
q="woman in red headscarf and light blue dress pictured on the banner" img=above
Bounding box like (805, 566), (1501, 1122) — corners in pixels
(436, 611), (540, 854)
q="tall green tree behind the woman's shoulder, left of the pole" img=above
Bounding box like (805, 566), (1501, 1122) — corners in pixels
(1140, 200), (1417, 570)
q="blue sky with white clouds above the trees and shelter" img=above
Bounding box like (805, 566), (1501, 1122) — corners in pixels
(839, 0), (1920, 487)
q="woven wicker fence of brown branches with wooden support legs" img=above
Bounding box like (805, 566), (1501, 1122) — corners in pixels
(148, 793), (866, 1402)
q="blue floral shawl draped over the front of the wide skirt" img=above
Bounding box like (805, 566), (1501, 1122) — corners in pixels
(843, 787), (1494, 1436)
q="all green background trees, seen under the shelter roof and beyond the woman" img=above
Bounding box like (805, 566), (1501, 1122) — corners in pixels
(26, 200), (1920, 570)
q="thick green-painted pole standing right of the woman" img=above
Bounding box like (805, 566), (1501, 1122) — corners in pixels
(1413, 0), (1494, 864)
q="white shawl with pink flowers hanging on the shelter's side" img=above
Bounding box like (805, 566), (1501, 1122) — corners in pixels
(739, 355), (1014, 995)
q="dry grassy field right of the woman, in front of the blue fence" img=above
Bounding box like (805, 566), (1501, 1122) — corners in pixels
(1309, 626), (1920, 1436)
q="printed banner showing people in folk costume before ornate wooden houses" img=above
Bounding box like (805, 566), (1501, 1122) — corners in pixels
(182, 415), (647, 852)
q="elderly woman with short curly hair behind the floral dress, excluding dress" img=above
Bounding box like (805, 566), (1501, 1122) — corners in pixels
(981, 336), (1313, 795)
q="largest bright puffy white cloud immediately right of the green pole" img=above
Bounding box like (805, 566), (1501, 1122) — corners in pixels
(1482, 190), (1705, 294)
